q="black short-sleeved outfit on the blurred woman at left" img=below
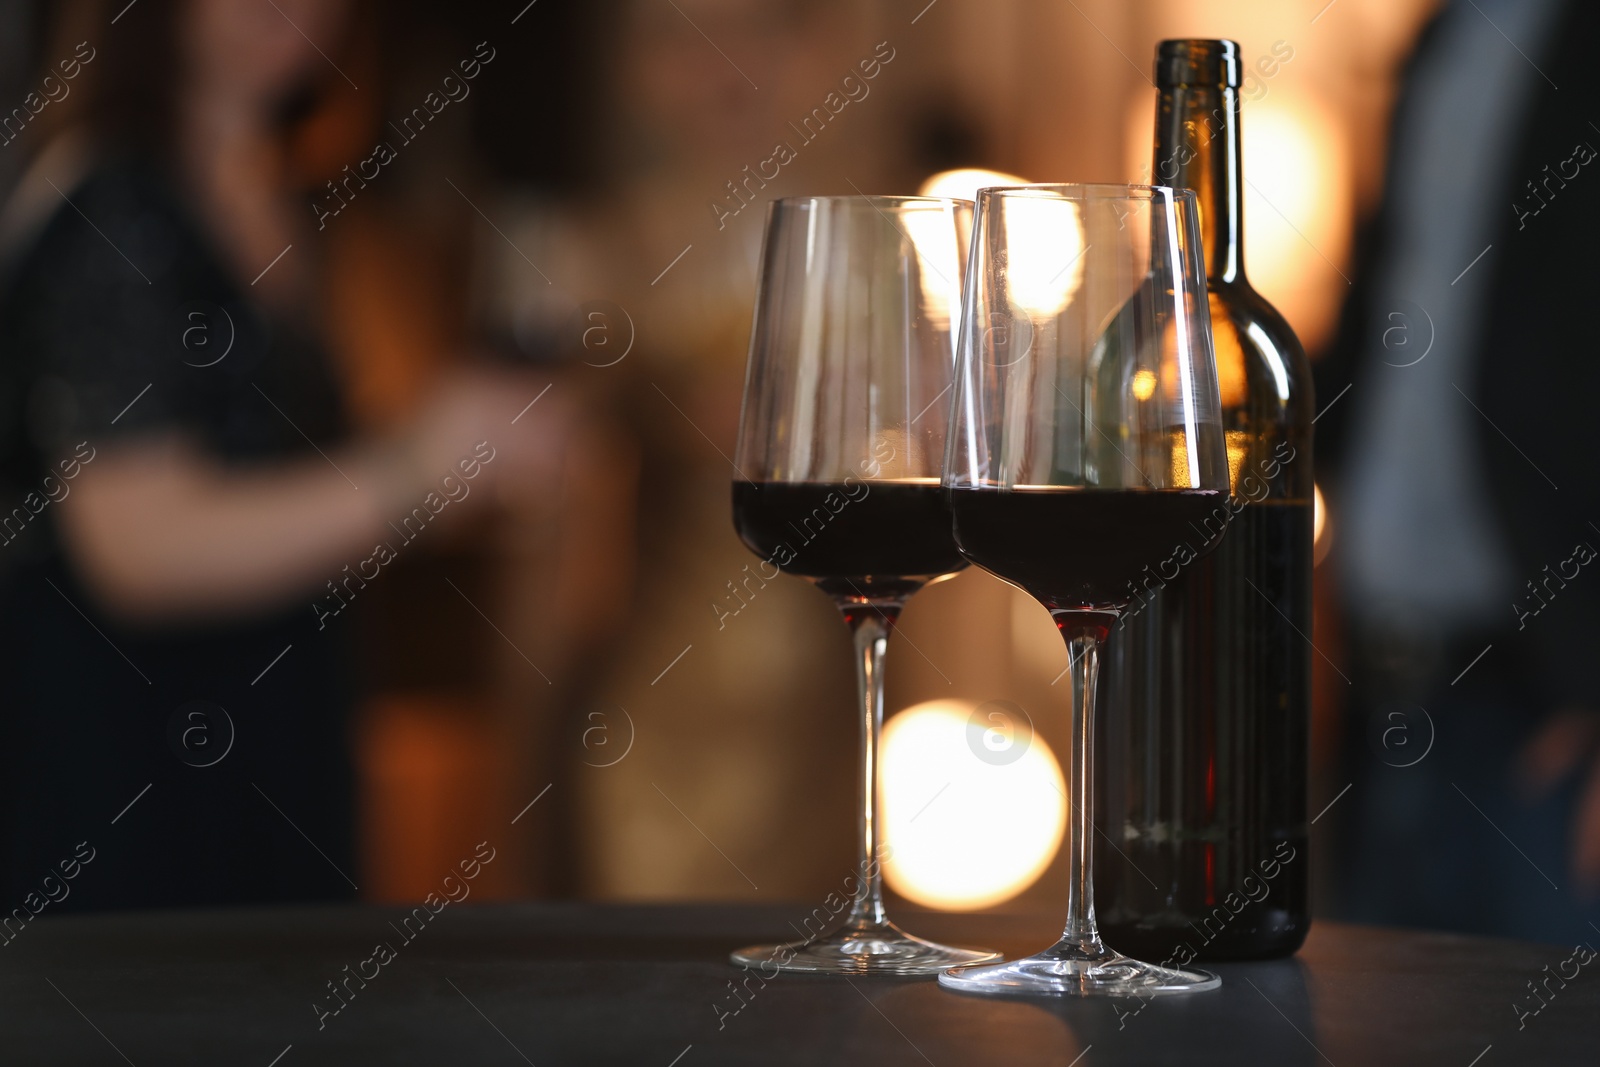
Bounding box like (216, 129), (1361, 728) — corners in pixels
(0, 160), (355, 921)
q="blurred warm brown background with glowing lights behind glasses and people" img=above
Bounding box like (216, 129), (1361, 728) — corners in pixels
(0, 0), (1435, 912)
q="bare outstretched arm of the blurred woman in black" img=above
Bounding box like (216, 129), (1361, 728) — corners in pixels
(59, 376), (562, 621)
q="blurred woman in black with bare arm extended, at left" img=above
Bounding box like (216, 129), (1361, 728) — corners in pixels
(0, 0), (563, 913)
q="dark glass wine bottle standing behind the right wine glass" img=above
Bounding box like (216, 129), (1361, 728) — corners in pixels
(1094, 40), (1314, 965)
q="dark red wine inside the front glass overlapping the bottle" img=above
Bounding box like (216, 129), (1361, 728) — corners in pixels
(950, 486), (1227, 611)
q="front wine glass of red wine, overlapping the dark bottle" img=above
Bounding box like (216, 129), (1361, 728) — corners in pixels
(939, 186), (1230, 997)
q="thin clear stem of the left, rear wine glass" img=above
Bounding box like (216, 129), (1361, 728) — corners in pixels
(840, 601), (901, 928)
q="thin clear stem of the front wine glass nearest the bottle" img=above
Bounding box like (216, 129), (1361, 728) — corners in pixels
(1058, 617), (1104, 955)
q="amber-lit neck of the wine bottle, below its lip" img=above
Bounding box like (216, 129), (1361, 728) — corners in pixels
(1154, 85), (1245, 285)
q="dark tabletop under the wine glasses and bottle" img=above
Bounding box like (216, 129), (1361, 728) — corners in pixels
(0, 904), (1600, 1067)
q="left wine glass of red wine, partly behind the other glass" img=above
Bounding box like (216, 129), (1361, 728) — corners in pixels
(733, 197), (998, 974)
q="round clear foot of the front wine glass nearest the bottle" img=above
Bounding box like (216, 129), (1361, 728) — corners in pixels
(939, 941), (1222, 997)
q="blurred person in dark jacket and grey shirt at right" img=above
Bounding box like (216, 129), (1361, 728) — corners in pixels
(1314, 0), (1600, 941)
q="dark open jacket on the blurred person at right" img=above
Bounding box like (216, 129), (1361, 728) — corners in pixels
(1315, 0), (1600, 713)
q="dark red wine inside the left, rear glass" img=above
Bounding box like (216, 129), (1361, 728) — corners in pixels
(733, 478), (966, 598)
